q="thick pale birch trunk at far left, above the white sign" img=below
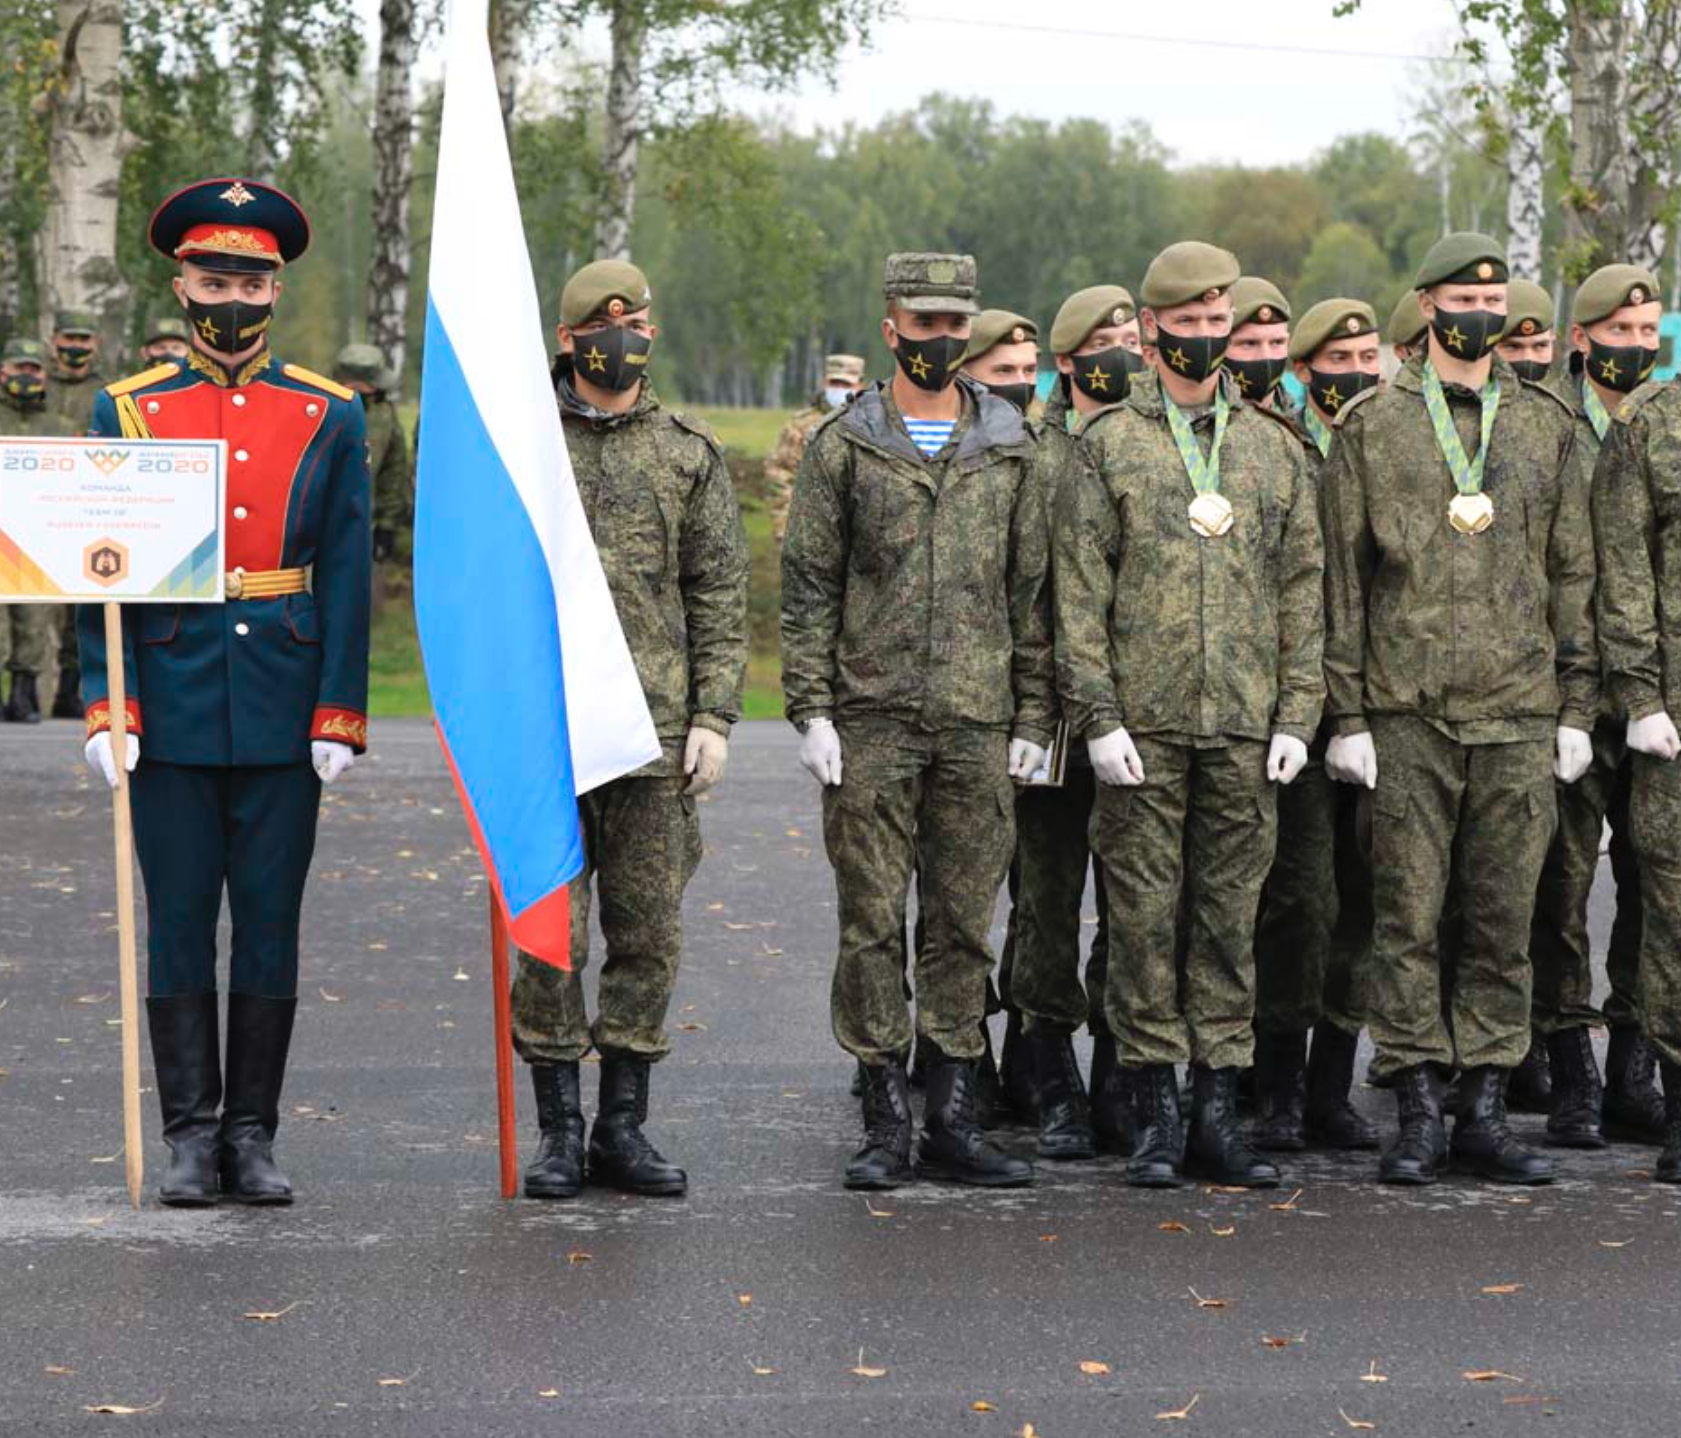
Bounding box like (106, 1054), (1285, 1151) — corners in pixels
(39, 0), (128, 346)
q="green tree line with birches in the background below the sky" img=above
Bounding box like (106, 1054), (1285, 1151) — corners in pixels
(0, 0), (1681, 405)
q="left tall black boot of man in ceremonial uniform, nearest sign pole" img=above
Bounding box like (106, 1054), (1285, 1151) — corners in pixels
(146, 994), (222, 1208)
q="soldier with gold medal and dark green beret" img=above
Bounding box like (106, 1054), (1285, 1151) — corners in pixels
(1321, 234), (1599, 1184)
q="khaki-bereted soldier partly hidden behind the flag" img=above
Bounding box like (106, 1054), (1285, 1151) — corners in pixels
(513, 261), (748, 1197)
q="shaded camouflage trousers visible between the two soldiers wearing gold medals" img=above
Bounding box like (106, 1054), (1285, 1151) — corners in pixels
(1256, 762), (1372, 1034)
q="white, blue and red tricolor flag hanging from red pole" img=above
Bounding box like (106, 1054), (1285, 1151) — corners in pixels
(415, 0), (661, 967)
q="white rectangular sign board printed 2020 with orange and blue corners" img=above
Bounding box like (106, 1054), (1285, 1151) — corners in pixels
(0, 437), (227, 604)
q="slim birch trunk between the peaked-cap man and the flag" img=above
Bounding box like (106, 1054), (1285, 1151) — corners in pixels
(368, 0), (419, 388)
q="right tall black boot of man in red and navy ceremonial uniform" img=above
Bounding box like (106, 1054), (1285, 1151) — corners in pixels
(222, 994), (298, 1204)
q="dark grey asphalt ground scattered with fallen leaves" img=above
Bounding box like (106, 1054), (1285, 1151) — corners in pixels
(0, 722), (1681, 1438)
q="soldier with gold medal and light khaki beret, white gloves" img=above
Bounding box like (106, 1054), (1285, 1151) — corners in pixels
(1052, 241), (1325, 1187)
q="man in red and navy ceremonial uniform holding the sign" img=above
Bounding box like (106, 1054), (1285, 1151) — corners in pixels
(79, 180), (368, 1206)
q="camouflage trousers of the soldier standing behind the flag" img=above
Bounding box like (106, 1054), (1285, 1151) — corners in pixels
(513, 777), (701, 1063)
